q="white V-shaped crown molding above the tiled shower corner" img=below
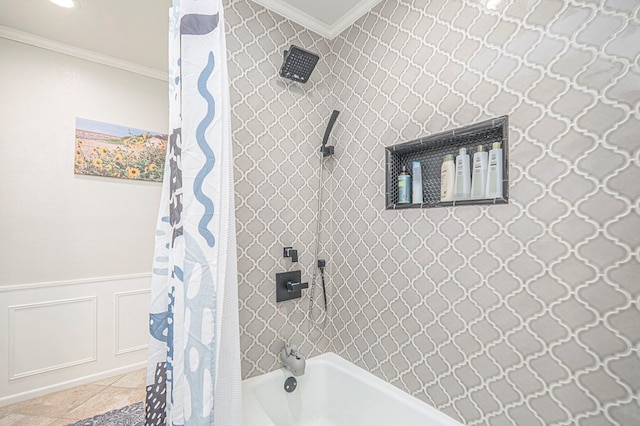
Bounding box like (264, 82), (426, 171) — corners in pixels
(253, 0), (382, 39)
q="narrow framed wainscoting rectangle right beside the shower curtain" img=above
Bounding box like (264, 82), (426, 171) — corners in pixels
(115, 290), (151, 355)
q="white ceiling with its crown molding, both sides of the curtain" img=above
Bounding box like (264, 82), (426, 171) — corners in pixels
(0, 0), (381, 77)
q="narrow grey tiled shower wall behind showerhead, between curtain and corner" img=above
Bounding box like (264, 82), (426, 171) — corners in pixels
(224, 0), (335, 377)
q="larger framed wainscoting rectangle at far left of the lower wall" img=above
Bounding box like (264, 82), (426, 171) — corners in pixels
(9, 296), (97, 380)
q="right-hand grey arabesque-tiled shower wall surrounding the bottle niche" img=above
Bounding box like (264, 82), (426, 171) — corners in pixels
(329, 0), (640, 426)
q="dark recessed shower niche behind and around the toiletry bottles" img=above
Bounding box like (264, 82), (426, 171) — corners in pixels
(385, 115), (509, 210)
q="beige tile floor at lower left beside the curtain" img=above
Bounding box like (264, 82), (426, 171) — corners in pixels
(0, 369), (146, 426)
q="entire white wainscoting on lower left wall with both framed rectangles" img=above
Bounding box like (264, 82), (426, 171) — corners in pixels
(0, 273), (151, 407)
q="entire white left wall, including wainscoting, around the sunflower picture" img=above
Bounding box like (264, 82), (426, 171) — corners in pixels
(0, 38), (168, 406)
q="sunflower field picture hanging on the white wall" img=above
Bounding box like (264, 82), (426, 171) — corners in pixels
(74, 118), (168, 182)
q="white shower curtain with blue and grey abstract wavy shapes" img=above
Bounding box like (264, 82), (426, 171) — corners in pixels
(145, 0), (242, 426)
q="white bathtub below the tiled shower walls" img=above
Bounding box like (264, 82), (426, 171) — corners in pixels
(242, 353), (461, 426)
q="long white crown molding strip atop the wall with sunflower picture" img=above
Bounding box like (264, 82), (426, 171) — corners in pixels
(0, 25), (169, 81)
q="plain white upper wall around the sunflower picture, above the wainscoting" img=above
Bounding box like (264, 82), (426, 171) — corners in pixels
(0, 39), (168, 285)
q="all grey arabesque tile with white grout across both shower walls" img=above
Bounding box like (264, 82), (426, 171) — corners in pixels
(225, 0), (640, 426)
